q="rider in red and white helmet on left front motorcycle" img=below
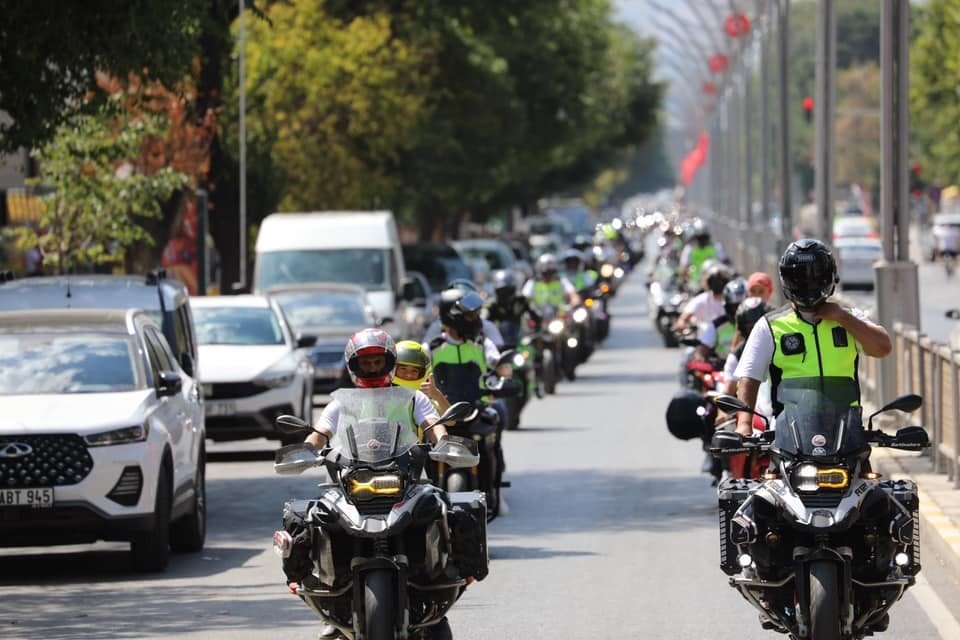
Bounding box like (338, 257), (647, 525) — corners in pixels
(305, 329), (453, 640)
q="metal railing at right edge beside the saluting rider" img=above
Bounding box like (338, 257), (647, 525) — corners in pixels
(860, 322), (960, 489)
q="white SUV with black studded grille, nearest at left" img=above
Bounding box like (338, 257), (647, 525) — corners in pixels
(0, 309), (206, 571)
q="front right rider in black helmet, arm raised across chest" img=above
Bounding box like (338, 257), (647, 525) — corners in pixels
(735, 238), (892, 435)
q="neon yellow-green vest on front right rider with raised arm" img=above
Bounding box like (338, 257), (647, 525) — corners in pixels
(766, 305), (859, 415)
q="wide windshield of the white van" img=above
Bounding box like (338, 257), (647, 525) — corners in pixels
(257, 249), (390, 291)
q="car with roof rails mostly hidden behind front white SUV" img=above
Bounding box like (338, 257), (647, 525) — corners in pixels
(0, 269), (198, 378)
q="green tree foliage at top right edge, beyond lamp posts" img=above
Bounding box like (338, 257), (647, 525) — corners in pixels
(910, 0), (960, 184)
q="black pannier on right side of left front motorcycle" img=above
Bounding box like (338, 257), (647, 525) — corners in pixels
(447, 491), (489, 580)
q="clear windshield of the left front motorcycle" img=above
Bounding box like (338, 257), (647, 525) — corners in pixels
(330, 387), (418, 464)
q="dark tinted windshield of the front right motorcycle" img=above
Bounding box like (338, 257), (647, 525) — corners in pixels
(774, 377), (868, 457)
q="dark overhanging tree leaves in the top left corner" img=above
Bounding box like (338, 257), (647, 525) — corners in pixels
(0, 0), (207, 151)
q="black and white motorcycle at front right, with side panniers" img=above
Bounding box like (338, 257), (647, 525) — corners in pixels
(711, 377), (929, 640)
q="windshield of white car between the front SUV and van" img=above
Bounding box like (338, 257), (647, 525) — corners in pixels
(193, 307), (284, 345)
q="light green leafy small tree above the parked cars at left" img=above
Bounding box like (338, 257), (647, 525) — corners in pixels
(5, 95), (188, 273)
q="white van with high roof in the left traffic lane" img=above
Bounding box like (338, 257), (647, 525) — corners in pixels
(253, 211), (408, 338)
